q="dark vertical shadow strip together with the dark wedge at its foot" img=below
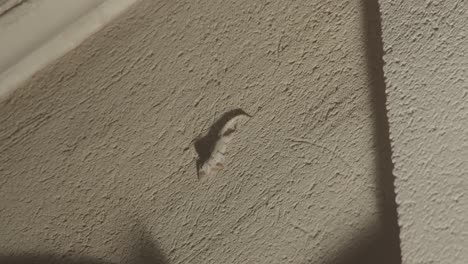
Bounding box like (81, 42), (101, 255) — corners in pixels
(310, 0), (401, 264)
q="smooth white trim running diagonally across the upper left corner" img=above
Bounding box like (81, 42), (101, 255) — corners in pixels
(0, 0), (138, 100)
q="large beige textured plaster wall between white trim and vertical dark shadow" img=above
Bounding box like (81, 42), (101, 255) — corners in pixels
(0, 0), (399, 263)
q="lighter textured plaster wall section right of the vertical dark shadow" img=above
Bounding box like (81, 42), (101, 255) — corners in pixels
(381, 1), (468, 263)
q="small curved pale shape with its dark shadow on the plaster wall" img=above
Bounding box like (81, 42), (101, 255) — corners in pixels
(194, 108), (251, 179)
